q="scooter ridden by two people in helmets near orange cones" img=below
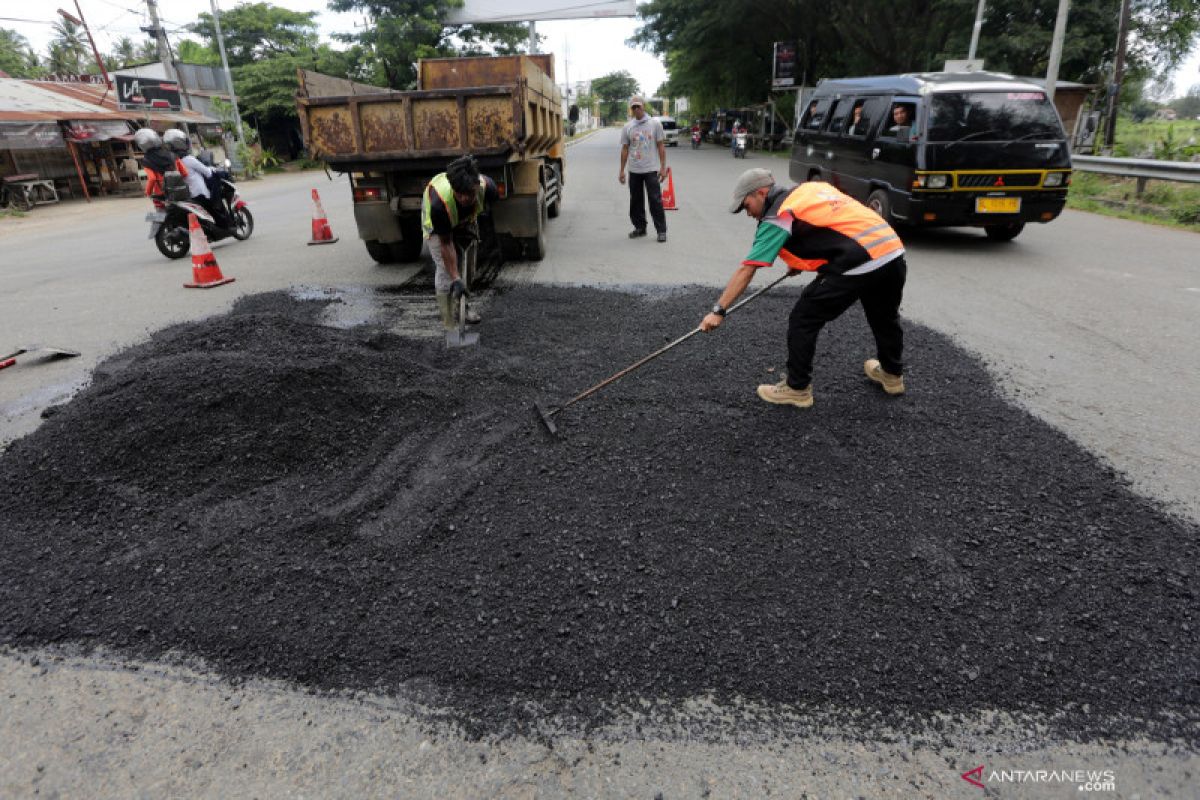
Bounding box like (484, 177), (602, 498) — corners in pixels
(146, 161), (254, 258)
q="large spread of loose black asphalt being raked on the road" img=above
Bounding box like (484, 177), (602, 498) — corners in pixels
(0, 287), (1200, 741)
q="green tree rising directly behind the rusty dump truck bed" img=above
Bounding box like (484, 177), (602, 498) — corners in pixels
(329, 0), (528, 89)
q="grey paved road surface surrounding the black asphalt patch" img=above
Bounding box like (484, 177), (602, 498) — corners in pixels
(0, 131), (1200, 798)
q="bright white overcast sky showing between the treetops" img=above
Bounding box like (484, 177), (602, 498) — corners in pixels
(0, 0), (1200, 96)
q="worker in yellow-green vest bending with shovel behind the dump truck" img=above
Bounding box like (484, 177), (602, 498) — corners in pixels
(421, 156), (499, 331)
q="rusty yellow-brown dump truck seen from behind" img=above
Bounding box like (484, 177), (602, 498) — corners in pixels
(296, 54), (564, 268)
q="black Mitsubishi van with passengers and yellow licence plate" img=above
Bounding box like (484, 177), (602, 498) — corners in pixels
(790, 72), (1070, 241)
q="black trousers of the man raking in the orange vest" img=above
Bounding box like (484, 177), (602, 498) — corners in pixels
(787, 255), (908, 389)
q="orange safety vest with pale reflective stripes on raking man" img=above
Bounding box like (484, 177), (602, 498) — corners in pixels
(778, 181), (904, 275)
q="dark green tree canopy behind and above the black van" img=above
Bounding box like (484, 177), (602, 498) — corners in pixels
(631, 0), (1200, 118)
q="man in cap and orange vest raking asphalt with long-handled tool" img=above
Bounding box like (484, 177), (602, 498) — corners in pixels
(700, 168), (907, 408)
